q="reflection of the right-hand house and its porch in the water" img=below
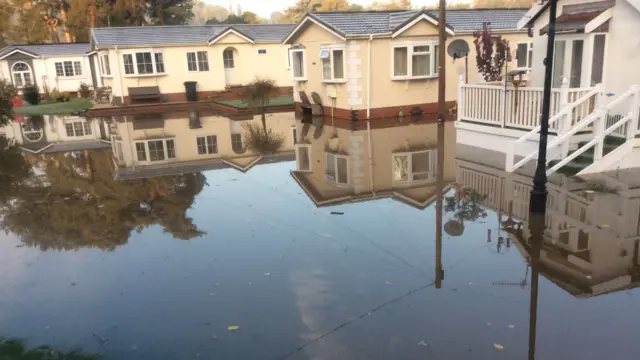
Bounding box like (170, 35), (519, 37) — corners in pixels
(456, 146), (640, 297)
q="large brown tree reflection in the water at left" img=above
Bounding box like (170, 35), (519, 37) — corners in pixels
(0, 150), (206, 250)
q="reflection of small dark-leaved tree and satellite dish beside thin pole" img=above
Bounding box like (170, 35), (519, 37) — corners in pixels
(444, 187), (487, 236)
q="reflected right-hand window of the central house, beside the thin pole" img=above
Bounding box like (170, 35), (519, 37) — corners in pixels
(392, 150), (437, 183)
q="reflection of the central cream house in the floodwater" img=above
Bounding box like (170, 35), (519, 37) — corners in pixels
(292, 119), (455, 209)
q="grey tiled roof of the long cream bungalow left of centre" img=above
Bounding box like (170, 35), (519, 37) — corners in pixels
(91, 24), (294, 46)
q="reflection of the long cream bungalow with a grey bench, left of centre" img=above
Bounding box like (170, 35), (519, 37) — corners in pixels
(112, 112), (295, 179)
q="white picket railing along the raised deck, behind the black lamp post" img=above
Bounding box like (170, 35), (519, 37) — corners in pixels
(458, 77), (595, 132)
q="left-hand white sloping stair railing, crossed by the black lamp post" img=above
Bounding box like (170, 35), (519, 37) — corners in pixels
(505, 84), (602, 172)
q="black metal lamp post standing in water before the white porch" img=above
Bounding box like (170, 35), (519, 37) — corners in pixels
(529, 0), (558, 213)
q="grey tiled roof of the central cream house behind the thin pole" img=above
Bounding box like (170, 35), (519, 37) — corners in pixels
(309, 9), (527, 35)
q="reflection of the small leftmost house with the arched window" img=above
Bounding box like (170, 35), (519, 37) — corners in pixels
(0, 115), (111, 154)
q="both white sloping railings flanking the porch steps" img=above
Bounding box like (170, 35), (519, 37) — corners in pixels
(505, 85), (640, 175)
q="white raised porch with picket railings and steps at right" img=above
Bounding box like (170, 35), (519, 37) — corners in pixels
(456, 75), (640, 175)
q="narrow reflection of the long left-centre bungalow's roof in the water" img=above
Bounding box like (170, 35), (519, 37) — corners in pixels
(113, 152), (296, 180)
